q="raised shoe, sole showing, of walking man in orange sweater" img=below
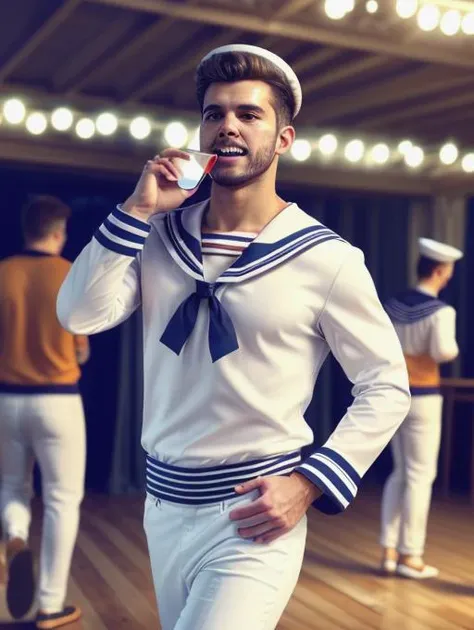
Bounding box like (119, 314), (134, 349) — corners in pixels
(6, 538), (35, 619)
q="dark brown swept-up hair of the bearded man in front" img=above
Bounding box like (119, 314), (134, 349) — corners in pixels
(196, 52), (295, 127)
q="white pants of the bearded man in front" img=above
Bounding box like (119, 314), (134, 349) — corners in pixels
(144, 492), (306, 630)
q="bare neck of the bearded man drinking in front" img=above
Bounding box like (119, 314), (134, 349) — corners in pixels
(203, 182), (288, 233)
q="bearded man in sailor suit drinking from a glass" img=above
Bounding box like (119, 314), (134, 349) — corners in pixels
(58, 45), (410, 630)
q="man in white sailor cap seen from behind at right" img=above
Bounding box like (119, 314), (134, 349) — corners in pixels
(381, 238), (462, 579)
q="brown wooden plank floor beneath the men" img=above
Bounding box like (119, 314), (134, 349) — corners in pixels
(0, 492), (474, 630)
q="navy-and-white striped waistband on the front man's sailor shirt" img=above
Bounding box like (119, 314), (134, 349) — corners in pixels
(146, 451), (301, 505)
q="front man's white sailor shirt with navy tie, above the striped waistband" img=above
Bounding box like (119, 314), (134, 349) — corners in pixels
(58, 202), (410, 512)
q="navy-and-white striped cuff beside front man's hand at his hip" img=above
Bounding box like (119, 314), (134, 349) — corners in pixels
(295, 446), (361, 514)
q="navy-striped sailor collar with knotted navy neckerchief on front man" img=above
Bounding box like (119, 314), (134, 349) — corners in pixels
(154, 201), (342, 362)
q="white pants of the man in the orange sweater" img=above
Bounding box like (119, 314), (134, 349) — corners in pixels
(0, 394), (86, 612)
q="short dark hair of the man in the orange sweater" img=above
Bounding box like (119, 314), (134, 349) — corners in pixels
(22, 195), (71, 241)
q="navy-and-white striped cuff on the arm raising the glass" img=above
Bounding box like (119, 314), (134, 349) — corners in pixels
(94, 206), (151, 257)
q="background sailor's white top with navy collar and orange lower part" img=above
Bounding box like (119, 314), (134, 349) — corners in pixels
(386, 285), (459, 396)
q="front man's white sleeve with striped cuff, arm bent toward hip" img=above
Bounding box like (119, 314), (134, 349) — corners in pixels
(295, 249), (410, 514)
